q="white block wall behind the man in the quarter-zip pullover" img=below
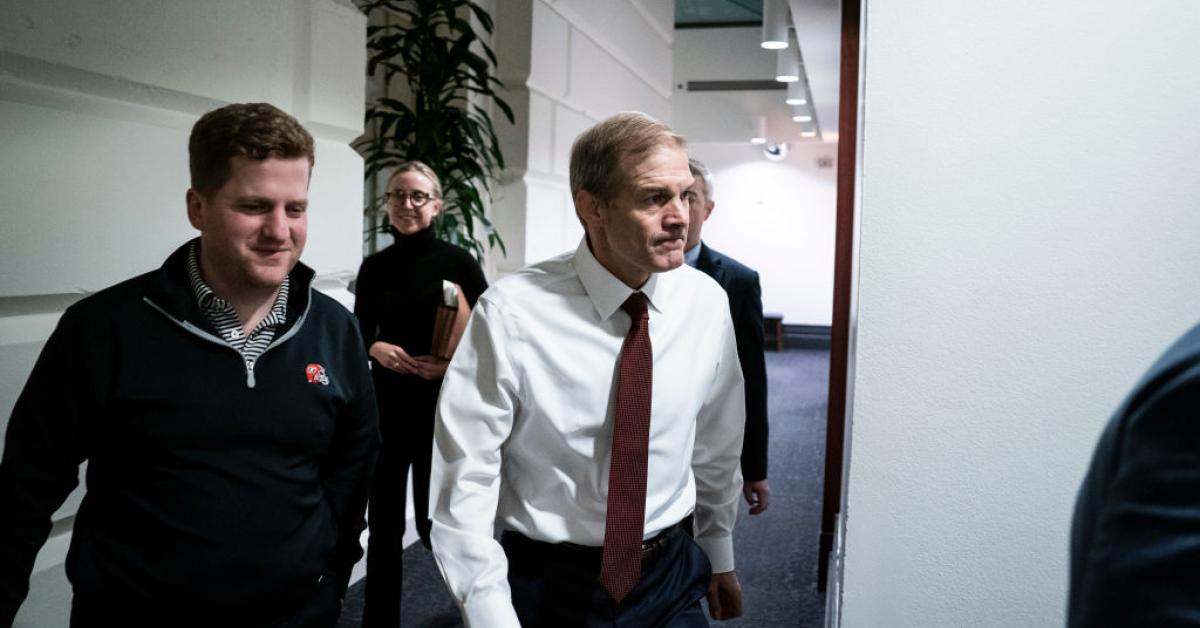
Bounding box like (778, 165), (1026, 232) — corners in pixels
(0, 0), (365, 628)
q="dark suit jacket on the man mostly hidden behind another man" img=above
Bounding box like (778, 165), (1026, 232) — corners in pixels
(696, 243), (768, 482)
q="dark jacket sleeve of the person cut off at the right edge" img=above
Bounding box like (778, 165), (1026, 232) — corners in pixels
(1067, 327), (1200, 628)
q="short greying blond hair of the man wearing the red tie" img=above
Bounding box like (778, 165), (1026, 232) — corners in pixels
(570, 112), (686, 204)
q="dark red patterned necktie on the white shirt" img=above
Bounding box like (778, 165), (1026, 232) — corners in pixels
(600, 292), (654, 603)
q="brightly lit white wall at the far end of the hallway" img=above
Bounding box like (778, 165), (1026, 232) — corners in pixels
(688, 142), (838, 325)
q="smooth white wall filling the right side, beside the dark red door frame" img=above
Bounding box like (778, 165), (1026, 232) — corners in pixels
(842, 0), (1200, 628)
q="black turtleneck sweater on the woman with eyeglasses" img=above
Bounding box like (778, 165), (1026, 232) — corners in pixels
(354, 229), (487, 377)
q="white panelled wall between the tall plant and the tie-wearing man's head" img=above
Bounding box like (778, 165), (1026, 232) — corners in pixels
(493, 0), (674, 273)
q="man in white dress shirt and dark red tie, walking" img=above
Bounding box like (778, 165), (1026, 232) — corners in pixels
(430, 113), (745, 628)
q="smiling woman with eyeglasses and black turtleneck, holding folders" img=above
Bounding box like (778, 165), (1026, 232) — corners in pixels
(354, 161), (487, 628)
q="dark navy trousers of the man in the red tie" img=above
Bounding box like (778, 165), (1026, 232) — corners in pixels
(500, 532), (713, 628)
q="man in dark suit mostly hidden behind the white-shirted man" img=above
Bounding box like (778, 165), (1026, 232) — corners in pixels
(684, 159), (770, 515)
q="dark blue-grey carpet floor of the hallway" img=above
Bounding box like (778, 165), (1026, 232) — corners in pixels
(337, 349), (829, 628)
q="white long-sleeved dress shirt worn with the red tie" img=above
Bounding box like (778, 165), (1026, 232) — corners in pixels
(430, 241), (745, 628)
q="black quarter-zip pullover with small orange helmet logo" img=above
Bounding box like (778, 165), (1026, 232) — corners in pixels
(0, 245), (379, 626)
